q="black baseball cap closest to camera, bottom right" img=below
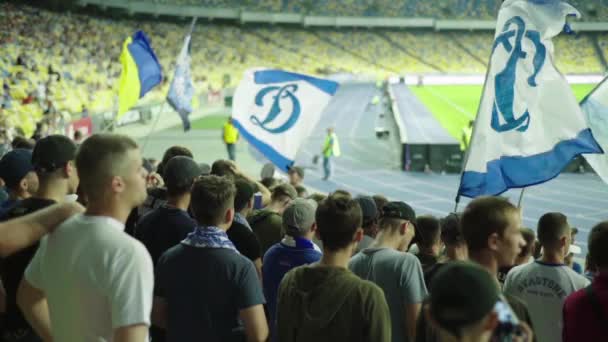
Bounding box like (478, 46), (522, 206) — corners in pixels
(429, 261), (499, 330)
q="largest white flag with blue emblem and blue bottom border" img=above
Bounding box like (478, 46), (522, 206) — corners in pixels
(458, 0), (602, 197)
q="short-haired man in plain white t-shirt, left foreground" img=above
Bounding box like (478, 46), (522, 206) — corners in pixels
(17, 134), (154, 342)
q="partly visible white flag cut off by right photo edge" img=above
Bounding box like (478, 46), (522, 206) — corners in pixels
(581, 77), (608, 183)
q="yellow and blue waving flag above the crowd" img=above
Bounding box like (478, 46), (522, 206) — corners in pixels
(117, 31), (163, 119)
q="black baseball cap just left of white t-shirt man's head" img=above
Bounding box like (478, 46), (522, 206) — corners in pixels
(32, 134), (77, 173)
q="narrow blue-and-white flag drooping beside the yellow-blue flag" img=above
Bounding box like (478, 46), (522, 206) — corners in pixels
(167, 21), (194, 131)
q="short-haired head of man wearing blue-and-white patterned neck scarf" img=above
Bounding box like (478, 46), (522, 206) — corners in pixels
(190, 175), (236, 227)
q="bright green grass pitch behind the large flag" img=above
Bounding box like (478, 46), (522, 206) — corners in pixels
(410, 84), (595, 139)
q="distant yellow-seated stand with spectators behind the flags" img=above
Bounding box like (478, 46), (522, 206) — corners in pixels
(0, 1), (608, 135)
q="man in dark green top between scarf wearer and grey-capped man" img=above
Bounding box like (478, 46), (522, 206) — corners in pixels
(247, 184), (298, 255)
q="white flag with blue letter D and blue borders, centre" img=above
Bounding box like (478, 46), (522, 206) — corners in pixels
(232, 69), (338, 171)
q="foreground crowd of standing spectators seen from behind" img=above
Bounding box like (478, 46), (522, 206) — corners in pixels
(0, 125), (608, 342)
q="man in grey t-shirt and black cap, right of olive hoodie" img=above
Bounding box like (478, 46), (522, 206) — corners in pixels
(349, 202), (427, 342)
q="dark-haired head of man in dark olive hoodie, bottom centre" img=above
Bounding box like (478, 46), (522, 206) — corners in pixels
(316, 194), (363, 251)
